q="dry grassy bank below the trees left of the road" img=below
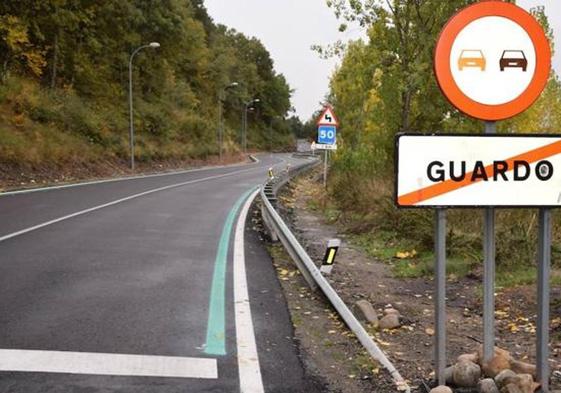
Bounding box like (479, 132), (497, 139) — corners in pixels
(0, 76), (291, 172)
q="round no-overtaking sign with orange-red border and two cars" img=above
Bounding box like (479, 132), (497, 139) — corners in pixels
(434, 1), (551, 121)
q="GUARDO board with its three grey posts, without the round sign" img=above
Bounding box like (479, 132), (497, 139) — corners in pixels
(395, 132), (561, 386)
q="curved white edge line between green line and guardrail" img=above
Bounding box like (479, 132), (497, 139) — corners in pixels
(234, 190), (265, 393)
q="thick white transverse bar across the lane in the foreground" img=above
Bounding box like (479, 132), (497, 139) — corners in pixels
(0, 349), (218, 379)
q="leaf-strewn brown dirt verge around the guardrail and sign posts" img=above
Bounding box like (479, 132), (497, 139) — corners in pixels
(258, 173), (561, 393)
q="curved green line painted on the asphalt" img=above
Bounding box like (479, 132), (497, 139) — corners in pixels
(204, 188), (255, 355)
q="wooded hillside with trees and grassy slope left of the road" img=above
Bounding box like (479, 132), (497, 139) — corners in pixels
(0, 0), (300, 179)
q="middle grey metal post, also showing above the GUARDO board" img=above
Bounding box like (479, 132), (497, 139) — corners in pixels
(483, 122), (497, 362)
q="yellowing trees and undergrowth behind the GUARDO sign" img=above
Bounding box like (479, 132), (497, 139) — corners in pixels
(317, 0), (561, 285)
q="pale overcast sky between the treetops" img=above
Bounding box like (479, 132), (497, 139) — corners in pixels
(205, 0), (561, 121)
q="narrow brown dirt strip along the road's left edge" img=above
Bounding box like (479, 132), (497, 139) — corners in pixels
(0, 154), (246, 192)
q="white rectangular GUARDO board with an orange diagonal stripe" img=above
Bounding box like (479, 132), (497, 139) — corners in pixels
(396, 134), (561, 207)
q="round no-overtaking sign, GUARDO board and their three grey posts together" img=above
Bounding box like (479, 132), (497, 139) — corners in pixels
(420, 0), (561, 386)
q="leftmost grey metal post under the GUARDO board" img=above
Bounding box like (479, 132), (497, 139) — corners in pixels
(434, 208), (446, 385)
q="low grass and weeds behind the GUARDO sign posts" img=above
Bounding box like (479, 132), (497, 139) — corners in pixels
(300, 162), (561, 287)
